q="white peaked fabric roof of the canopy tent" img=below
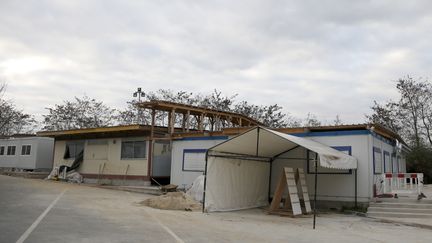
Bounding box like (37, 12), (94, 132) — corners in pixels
(209, 127), (357, 169)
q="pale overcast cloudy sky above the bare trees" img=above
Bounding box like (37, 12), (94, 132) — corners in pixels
(0, 0), (432, 123)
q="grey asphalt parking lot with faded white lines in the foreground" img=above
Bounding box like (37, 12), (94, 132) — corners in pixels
(0, 176), (432, 242)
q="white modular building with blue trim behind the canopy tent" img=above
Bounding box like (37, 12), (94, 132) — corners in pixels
(171, 124), (407, 206)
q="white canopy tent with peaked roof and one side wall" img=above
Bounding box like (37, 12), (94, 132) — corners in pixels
(203, 127), (357, 216)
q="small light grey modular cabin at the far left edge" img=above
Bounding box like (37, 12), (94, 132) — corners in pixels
(0, 136), (54, 171)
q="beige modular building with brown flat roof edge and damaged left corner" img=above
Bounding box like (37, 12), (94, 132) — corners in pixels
(38, 125), (171, 185)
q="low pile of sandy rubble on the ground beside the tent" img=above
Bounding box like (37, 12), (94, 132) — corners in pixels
(141, 192), (202, 211)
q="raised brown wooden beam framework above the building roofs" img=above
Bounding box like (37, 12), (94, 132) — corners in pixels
(138, 100), (262, 135)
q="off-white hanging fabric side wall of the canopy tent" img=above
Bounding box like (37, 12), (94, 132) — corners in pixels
(204, 157), (270, 212)
